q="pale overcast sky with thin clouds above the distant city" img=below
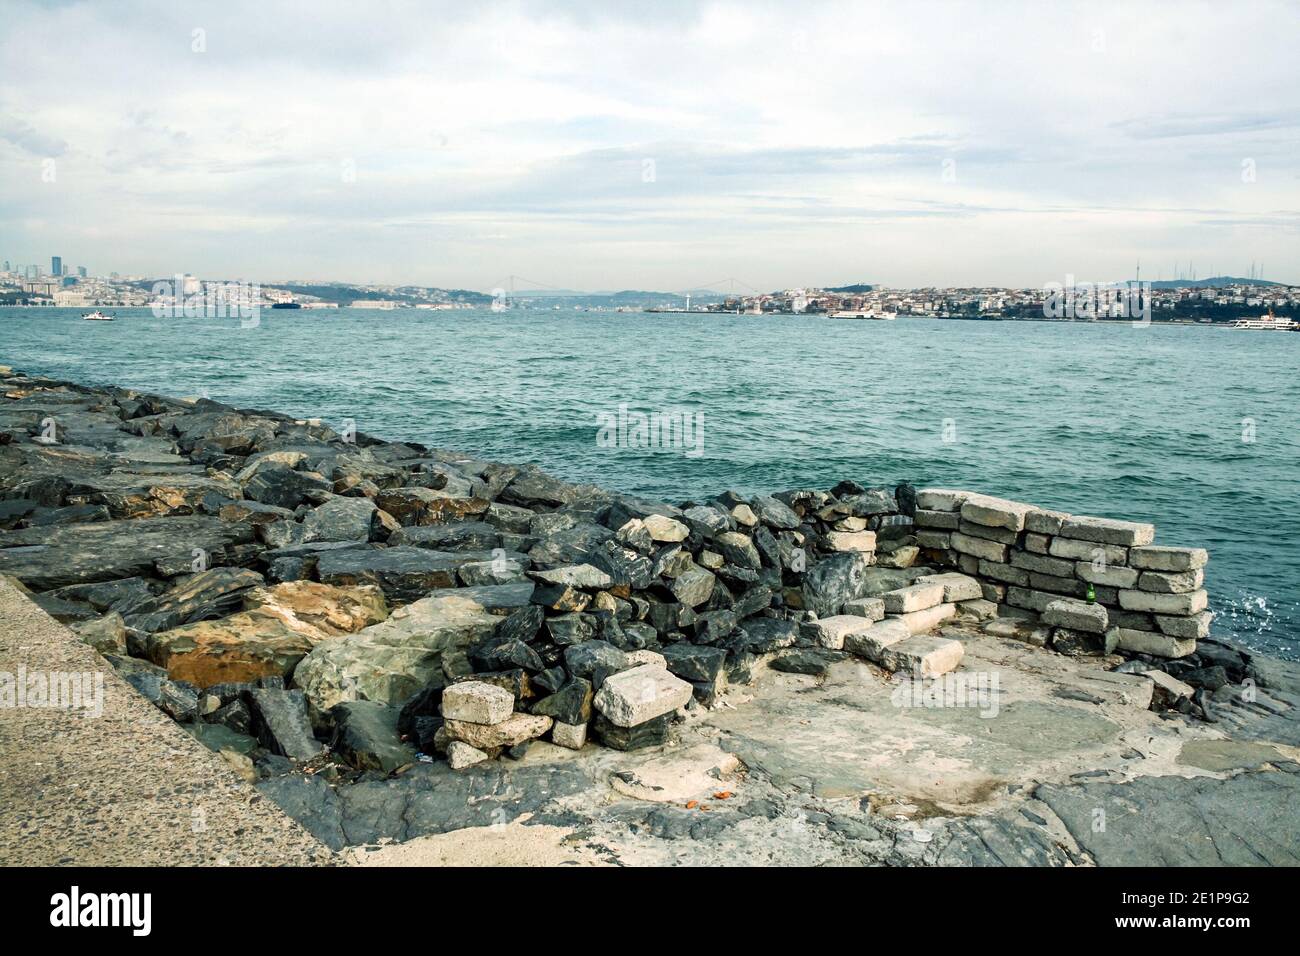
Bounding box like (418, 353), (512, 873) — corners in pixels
(0, 0), (1300, 291)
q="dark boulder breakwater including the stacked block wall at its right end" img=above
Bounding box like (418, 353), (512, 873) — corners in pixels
(0, 371), (1232, 778)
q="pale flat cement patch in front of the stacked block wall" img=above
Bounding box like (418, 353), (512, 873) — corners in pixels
(707, 634), (1133, 813)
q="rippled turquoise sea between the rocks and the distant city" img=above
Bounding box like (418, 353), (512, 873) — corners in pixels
(0, 308), (1300, 658)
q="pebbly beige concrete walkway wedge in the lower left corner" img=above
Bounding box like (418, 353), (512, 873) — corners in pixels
(0, 581), (333, 866)
